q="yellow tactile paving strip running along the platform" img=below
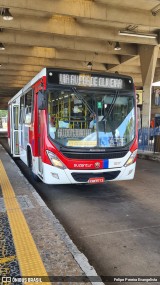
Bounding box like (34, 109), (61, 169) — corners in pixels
(0, 160), (51, 285)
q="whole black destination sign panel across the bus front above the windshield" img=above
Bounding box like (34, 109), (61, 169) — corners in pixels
(47, 70), (133, 90)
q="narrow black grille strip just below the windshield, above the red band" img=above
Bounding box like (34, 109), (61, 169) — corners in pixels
(62, 151), (128, 159)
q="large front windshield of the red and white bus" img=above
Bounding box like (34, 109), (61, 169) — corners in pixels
(47, 88), (135, 148)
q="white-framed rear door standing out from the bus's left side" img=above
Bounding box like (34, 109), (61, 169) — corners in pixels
(10, 104), (20, 157)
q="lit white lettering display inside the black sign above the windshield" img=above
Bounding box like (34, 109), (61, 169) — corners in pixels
(59, 73), (123, 89)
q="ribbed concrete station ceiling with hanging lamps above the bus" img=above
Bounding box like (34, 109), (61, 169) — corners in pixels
(0, 0), (160, 109)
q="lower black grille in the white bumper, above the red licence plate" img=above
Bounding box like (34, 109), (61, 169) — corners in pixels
(71, 171), (120, 182)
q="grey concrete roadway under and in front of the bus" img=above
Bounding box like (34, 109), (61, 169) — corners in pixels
(0, 136), (160, 276)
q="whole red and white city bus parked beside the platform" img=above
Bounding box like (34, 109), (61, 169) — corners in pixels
(8, 68), (137, 184)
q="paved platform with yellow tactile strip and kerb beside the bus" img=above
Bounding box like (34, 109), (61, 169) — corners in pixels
(0, 145), (101, 285)
